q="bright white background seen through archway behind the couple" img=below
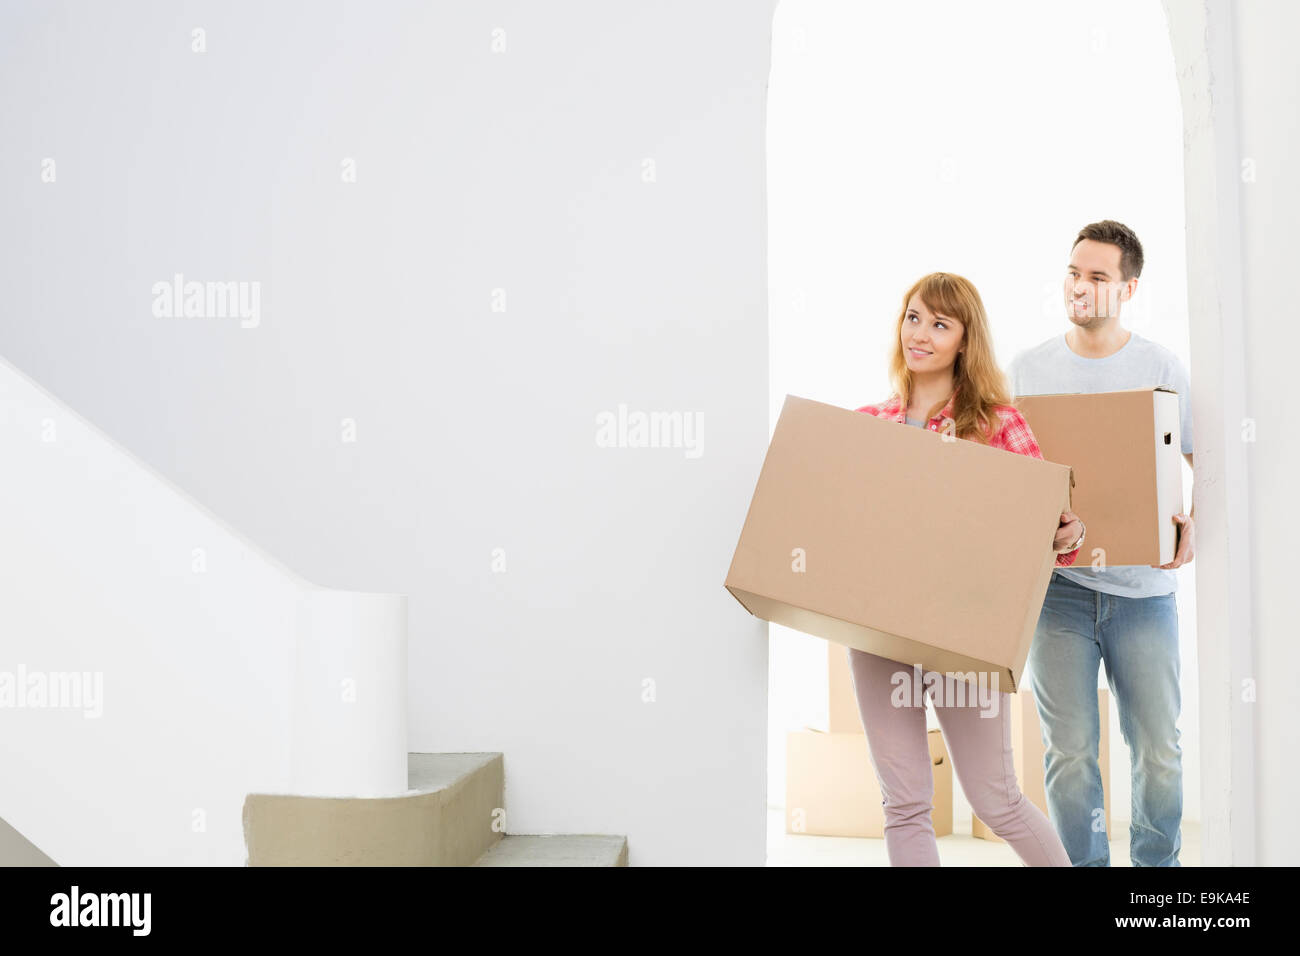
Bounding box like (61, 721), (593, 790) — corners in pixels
(768, 0), (1200, 831)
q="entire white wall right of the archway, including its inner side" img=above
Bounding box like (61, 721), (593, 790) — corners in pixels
(1166, 0), (1300, 865)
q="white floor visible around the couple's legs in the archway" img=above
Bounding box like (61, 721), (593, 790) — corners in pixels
(767, 806), (1201, 866)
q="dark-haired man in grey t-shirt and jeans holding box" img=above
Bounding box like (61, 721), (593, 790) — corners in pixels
(1008, 220), (1196, 866)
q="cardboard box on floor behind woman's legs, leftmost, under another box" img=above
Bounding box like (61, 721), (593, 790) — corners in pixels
(785, 730), (953, 838)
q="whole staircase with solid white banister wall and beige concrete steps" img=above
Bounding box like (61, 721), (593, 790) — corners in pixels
(0, 359), (627, 866)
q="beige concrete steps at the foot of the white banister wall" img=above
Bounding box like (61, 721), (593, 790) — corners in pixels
(243, 753), (628, 866)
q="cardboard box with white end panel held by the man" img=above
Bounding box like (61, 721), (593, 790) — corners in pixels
(1014, 385), (1183, 567)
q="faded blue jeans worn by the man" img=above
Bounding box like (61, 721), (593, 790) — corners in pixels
(1027, 574), (1183, 866)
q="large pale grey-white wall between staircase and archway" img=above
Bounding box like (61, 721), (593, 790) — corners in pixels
(0, 0), (774, 864)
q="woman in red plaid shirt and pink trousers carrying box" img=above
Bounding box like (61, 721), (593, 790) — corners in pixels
(849, 272), (1084, 866)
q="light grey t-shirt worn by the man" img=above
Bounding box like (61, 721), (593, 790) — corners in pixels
(1008, 332), (1192, 597)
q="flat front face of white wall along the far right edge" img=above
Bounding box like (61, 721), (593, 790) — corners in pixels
(1234, 0), (1300, 866)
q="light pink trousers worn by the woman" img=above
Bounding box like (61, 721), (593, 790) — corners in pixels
(845, 648), (1070, 866)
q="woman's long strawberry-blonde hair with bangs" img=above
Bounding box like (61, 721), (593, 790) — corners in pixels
(889, 272), (1011, 445)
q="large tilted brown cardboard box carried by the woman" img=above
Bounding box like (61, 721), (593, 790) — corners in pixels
(724, 395), (1071, 692)
